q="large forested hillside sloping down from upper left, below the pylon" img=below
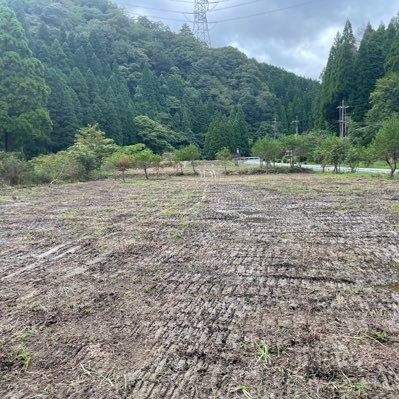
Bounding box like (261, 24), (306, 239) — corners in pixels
(0, 0), (319, 156)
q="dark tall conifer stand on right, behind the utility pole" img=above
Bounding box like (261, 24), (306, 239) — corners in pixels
(315, 17), (399, 145)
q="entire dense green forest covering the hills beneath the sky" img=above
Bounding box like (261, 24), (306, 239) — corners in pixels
(0, 0), (399, 158)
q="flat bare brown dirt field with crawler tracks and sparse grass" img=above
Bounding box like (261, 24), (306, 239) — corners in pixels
(0, 175), (399, 399)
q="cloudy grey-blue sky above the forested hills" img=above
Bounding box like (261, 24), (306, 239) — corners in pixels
(114, 0), (399, 79)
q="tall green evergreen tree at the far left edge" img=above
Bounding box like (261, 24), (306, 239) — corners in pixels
(0, 0), (51, 154)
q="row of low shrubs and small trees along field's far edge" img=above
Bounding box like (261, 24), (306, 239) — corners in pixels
(0, 114), (399, 184)
